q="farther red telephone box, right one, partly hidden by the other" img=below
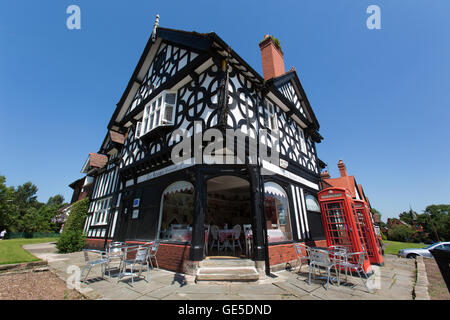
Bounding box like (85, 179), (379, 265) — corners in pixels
(353, 200), (383, 265)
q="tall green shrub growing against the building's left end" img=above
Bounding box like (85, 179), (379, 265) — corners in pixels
(56, 198), (89, 253)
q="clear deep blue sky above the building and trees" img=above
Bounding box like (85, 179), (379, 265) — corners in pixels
(0, 0), (450, 220)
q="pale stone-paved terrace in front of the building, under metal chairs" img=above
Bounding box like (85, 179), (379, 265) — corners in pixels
(24, 243), (416, 300)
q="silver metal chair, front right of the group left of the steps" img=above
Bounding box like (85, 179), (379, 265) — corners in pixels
(117, 243), (151, 287)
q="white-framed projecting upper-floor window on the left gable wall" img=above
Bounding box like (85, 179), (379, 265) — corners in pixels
(136, 91), (177, 138)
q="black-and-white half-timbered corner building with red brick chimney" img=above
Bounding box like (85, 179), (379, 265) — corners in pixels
(82, 27), (325, 271)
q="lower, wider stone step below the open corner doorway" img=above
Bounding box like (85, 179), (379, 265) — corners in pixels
(196, 267), (259, 281)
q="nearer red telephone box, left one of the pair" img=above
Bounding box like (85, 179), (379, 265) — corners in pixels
(318, 188), (372, 273)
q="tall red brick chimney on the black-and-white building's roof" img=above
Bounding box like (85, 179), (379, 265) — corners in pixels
(259, 34), (286, 80)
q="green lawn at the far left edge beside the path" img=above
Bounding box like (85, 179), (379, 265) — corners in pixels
(0, 238), (58, 264)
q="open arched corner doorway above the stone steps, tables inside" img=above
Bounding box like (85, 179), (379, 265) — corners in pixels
(205, 176), (253, 258)
